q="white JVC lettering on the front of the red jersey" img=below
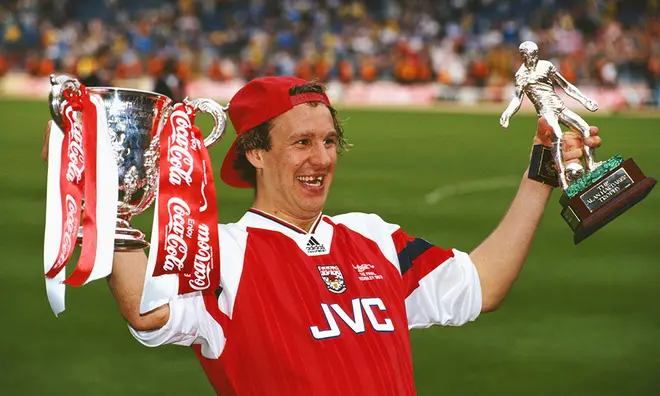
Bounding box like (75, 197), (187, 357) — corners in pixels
(309, 298), (394, 340)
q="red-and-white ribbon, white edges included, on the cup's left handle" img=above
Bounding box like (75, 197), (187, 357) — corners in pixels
(44, 86), (118, 315)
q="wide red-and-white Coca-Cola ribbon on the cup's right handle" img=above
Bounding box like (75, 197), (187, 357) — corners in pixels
(141, 103), (220, 312)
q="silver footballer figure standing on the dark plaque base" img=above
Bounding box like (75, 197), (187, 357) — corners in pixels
(500, 41), (599, 189)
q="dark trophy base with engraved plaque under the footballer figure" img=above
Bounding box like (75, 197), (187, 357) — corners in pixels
(559, 158), (656, 245)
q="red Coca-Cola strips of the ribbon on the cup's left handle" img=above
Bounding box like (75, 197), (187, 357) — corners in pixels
(46, 86), (97, 286)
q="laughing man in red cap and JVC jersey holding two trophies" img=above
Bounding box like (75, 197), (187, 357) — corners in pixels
(43, 77), (601, 395)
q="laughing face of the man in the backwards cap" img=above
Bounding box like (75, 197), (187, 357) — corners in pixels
(248, 104), (338, 219)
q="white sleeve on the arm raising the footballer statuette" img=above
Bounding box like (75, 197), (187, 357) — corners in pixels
(406, 249), (481, 329)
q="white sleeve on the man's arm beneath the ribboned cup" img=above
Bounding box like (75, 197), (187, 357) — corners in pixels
(128, 292), (226, 358)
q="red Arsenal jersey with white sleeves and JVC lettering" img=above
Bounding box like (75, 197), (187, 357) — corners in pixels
(131, 209), (481, 396)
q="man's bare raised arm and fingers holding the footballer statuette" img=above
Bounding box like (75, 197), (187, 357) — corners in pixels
(470, 118), (601, 312)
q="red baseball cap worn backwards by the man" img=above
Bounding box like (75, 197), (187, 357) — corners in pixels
(220, 77), (330, 188)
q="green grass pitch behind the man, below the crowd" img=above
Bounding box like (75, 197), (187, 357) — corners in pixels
(0, 100), (660, 396)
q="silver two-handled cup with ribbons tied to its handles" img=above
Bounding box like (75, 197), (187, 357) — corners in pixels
(48, 75), (227, 250)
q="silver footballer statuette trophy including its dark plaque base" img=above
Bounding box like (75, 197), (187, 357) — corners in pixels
(500, 41), (656, 244)
